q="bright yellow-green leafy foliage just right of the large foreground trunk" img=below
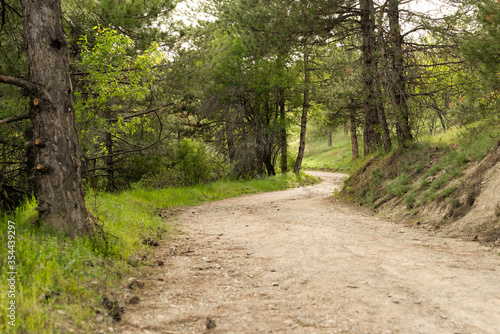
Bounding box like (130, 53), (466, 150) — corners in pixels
(75, 27), (163, 151)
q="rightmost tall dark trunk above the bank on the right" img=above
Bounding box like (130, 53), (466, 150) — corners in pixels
(388, 0), (413, 145)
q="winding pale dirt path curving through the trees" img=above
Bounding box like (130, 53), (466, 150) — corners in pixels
(116, 172), (500, 334)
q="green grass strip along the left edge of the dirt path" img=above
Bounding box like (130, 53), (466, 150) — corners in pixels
(0, 173), (314, 333)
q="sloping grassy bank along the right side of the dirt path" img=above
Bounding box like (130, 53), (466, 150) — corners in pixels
(340, 123), (500, 215)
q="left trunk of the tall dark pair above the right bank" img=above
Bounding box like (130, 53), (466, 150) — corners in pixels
(360, 0), (381, 156)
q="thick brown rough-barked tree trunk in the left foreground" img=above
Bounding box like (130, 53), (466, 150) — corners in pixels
(22, 0), (93, 237)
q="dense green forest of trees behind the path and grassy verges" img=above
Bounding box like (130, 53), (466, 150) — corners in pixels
(0, 0), (500, 210)
